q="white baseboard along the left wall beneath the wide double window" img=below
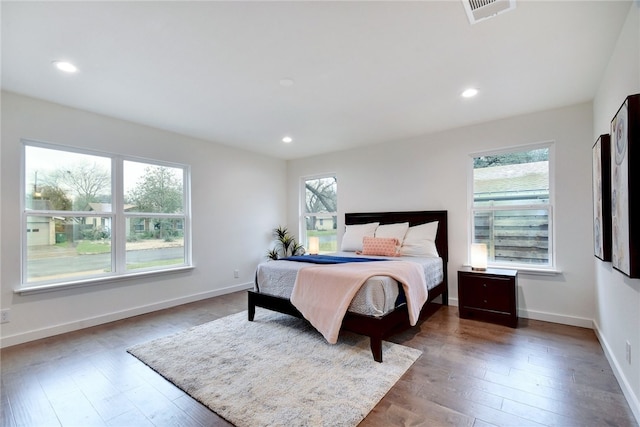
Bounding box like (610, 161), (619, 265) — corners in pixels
(0, 282), (253, 348)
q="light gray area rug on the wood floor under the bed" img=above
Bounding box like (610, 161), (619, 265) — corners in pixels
(127, 309), (422, 427)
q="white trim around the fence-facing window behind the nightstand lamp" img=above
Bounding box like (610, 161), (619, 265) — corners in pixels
(465, 141), (561, 275)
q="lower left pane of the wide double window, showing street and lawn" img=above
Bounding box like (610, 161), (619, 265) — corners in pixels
(25, 216), (112, 283)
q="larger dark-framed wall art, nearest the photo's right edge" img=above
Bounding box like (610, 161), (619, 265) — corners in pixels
(611, 94), (640, 278)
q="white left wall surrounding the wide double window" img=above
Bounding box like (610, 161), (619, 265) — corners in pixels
(0, 92), (286, 346)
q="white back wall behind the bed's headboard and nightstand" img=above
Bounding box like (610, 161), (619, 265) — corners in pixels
(287, 103), (595, 327)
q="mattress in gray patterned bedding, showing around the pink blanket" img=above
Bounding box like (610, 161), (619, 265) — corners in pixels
(255, 252), (444, 316)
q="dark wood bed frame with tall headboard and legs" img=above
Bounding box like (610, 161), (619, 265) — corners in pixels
(248, 211), (449, 362)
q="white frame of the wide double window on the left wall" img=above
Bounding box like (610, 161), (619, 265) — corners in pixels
(15, 138), (193, 294)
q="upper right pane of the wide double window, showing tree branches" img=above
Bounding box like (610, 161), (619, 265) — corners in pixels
(123, 161), (184, 213)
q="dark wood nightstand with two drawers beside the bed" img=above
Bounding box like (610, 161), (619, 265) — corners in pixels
(458, 267), (518, 328)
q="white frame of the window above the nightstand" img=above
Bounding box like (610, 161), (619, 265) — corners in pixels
(467, 141), (558, 274)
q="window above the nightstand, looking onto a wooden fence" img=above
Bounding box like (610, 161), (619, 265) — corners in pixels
(470, 144), (554, 269)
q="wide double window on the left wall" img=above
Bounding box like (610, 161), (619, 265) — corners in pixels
(22, 141), (190, 289)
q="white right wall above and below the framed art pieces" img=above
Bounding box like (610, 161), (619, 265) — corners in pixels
(592, 1), (640, 420)
